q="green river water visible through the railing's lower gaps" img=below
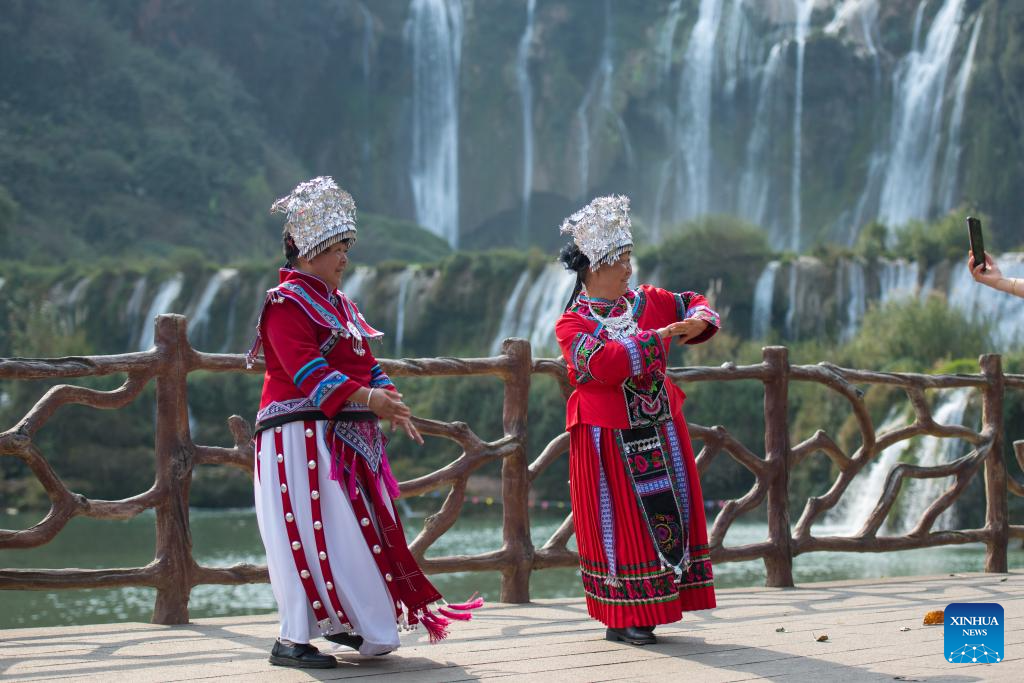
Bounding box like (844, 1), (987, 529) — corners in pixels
(0, 506), (1024, 629)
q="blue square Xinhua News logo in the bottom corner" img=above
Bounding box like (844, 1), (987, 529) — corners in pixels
(943, 602), (1006, 664)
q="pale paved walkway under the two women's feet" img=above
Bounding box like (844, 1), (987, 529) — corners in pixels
(0, 570), (1024, 683)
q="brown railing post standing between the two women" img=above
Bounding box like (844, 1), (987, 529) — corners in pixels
(501, 339), (534, 602)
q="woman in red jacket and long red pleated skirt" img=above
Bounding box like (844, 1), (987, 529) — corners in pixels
(555, 197), (719, 645)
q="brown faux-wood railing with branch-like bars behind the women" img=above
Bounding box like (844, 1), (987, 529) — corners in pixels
(0, 315), (1024, 624)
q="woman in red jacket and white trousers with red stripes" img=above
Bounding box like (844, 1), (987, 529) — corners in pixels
(249, 176), (476, 669)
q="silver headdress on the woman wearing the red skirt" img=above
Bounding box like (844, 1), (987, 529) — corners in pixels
(561, 195), (633, 270)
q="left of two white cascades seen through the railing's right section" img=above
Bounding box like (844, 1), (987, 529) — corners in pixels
(822, 405), (911, 536)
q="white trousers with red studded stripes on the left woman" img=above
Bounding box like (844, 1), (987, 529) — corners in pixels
(254, 421), (399, 655)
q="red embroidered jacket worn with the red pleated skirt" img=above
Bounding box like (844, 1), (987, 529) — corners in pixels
(555, 285), (721, 429)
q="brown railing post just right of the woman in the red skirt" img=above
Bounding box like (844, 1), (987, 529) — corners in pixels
(763, 346), (793, 588)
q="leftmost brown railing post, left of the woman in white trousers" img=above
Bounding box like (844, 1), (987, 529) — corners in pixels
(153, 315), (196, 624)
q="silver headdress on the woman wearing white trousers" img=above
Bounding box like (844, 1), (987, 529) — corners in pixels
(270, 175), (356, 258)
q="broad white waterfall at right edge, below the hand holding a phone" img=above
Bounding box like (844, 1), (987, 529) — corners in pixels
(947, 252), (1024, 349)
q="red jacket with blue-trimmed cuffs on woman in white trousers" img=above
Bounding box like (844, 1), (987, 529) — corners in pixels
(249, 268), (394, 431)
